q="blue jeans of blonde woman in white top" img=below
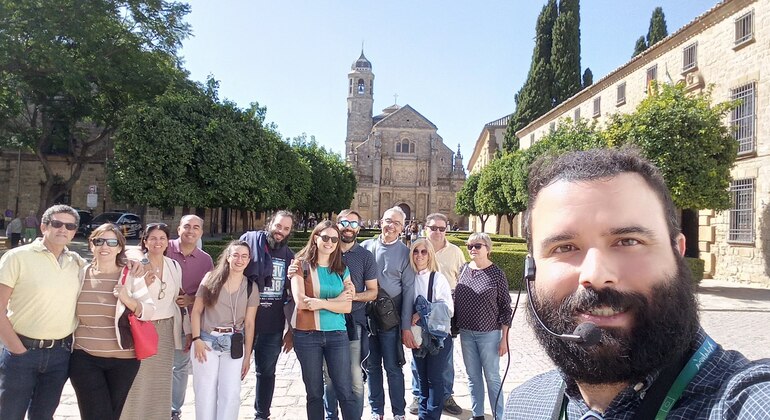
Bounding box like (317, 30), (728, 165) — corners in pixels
(412, 339), (453, 420)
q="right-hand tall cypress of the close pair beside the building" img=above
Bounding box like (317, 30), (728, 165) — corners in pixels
(551, 0), (582, 106)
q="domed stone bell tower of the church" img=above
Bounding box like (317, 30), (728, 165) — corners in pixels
(345, 48), (374, 156)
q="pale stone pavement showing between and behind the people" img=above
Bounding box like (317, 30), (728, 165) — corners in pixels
(46, 280), (770, 420)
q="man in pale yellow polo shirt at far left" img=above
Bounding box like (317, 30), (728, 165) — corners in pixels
(0, 205), (85, 420)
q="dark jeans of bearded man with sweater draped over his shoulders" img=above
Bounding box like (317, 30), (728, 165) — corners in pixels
(254, 332), (283, 419)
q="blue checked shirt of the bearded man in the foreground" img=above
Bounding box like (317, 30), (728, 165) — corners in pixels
(504, 329), (770, 420)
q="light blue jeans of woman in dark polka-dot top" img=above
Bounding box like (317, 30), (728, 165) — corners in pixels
(460, 329), (504, 418)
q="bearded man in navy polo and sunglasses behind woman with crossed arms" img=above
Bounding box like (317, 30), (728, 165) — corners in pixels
(324, 209), (377, 420)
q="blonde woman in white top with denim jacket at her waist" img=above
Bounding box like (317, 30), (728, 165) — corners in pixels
(409, 238), (454, 420)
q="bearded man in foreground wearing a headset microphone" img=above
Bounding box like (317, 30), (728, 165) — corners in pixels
(505, 149), (770, 420)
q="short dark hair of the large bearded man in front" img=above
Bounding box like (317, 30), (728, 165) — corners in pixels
(524, 147), (680, 252)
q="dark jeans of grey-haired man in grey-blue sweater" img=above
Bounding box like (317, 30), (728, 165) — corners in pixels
(367, 327), (406, 416)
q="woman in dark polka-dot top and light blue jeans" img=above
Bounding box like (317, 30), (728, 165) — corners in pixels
(455, 233), (512, 419)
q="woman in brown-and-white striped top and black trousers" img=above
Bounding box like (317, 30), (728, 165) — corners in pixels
(70, 223), (155, 420)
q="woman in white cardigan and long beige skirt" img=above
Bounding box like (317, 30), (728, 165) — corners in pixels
(120, 223), (189, 420)
